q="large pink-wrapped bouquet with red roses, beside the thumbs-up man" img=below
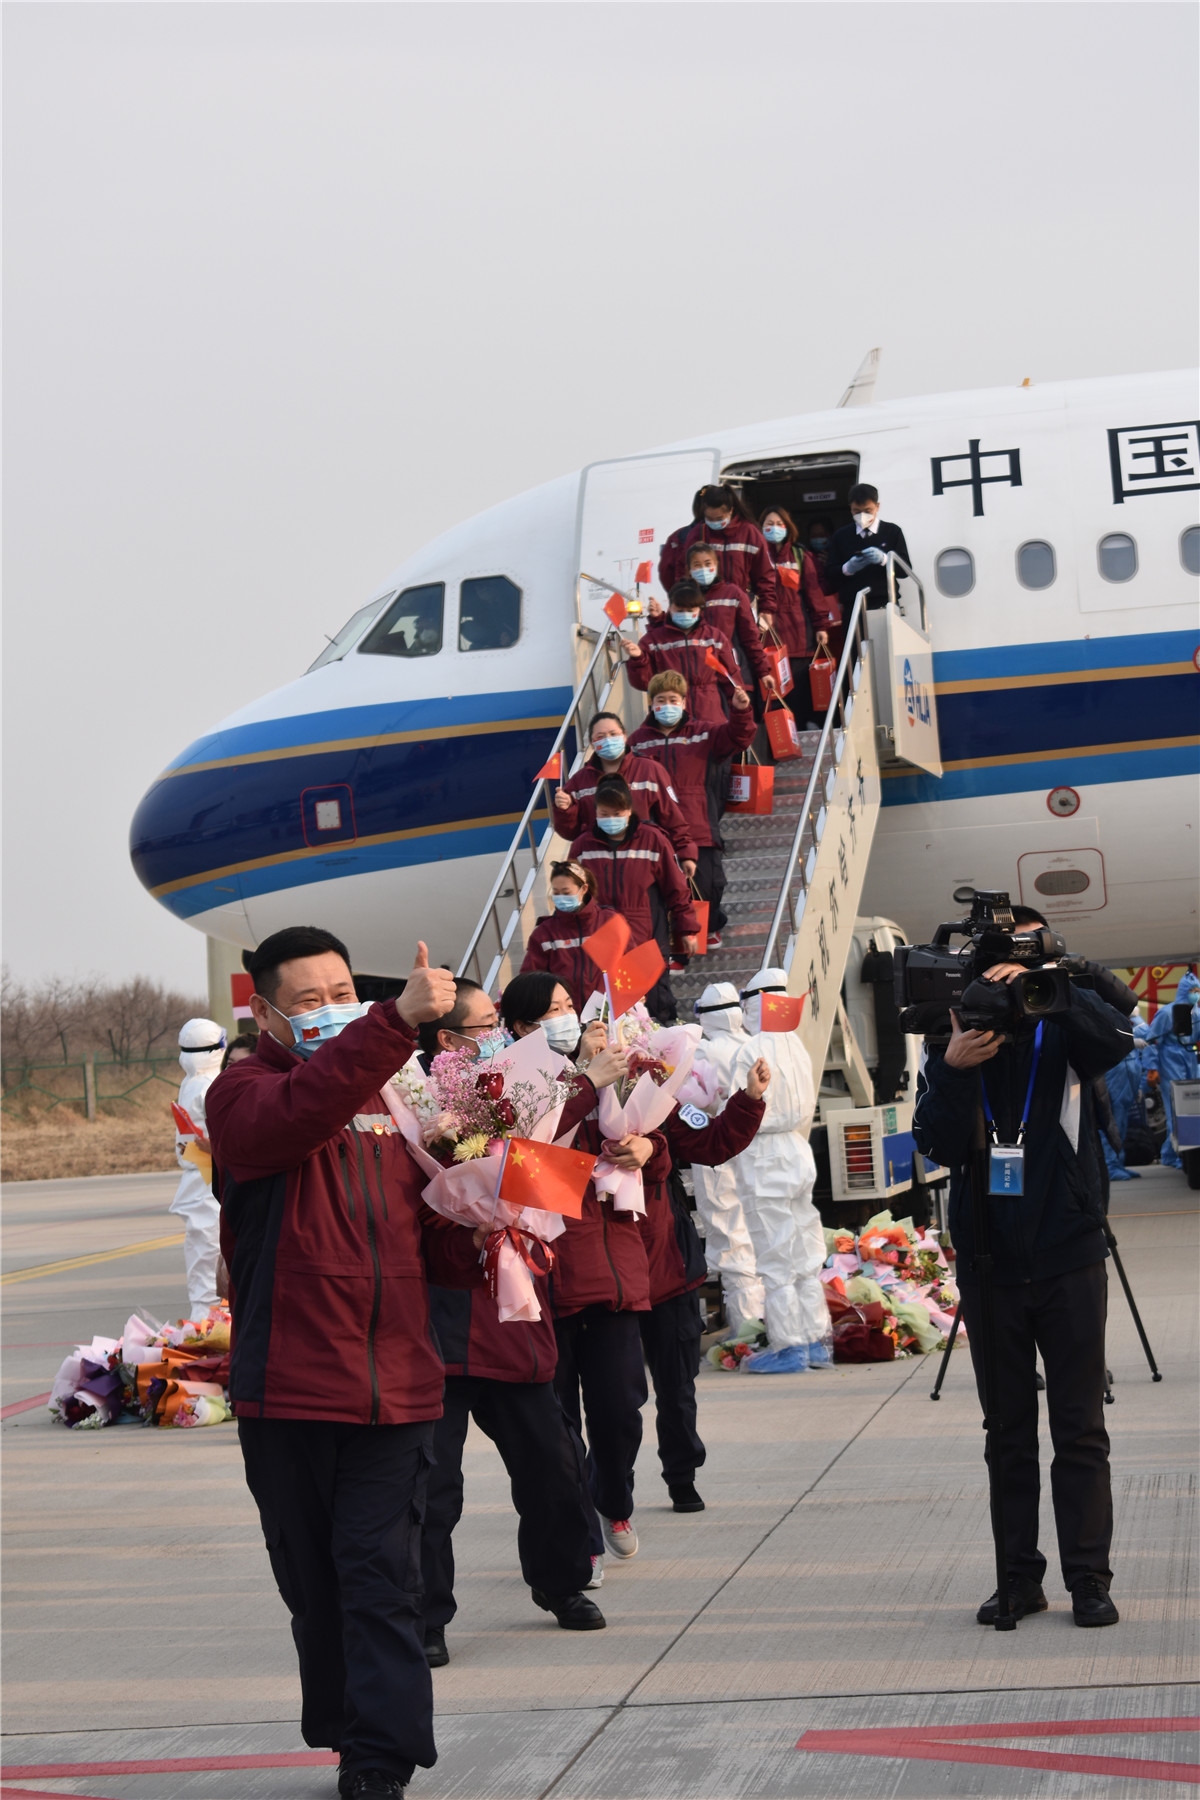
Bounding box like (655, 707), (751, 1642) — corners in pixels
(383, 1031), (586, 1323)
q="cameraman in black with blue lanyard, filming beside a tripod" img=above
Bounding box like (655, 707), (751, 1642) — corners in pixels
(912, 907), (1133, 1625)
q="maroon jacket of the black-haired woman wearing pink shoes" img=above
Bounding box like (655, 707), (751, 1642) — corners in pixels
(551, 1082), (671, 1319)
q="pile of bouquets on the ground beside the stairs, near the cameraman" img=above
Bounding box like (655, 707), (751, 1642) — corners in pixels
(820, 1211), (964, 1363)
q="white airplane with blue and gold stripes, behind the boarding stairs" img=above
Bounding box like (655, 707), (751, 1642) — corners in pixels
(131, 353), (1200, 1000)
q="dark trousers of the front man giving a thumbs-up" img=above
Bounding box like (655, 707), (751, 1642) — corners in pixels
(237, 1418), (437, 1780)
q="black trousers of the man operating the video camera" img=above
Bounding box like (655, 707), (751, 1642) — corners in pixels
(963, 1262), (1112, 1588)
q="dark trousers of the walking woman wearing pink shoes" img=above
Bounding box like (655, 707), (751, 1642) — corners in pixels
(554, 1307), (649, 1519)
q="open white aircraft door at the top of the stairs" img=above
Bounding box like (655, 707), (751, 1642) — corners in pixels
(576, 448), (720, 630)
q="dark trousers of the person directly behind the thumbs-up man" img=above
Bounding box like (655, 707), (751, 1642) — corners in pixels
(421, 1375), (592, 1625)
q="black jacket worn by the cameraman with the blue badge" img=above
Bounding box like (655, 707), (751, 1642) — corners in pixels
(912, 986), (1133, 1287)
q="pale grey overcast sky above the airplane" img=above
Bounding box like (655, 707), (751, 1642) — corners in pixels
(4, 0), (1196, 988)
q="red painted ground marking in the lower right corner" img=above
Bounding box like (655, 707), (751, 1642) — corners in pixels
(795, 1717), (1200, 1787)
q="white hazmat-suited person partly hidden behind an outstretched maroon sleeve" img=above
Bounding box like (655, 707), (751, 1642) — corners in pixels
(691, 981), (763, 1330)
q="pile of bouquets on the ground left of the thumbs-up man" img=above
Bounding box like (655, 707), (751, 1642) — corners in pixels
(50, 1301), (234, 1431)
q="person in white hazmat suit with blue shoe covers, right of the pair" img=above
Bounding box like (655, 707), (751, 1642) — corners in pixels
(730, 968), (831, 1375)
